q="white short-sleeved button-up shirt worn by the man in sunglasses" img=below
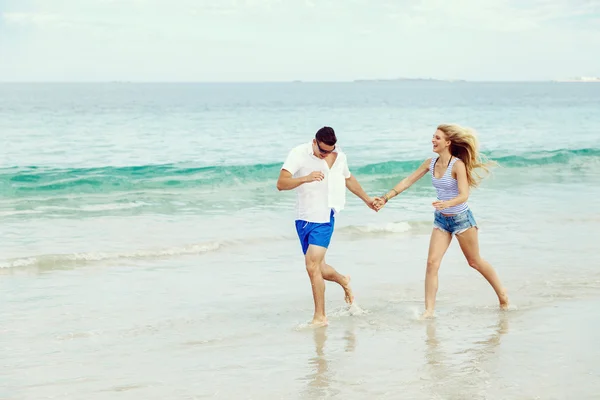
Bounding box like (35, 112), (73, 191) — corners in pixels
(281, 141), (351, 223)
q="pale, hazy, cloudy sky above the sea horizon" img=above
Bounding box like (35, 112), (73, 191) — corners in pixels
(0, 0), (600, 82)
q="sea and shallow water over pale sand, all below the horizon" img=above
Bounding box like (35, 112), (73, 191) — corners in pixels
(0, 82), (600, 400)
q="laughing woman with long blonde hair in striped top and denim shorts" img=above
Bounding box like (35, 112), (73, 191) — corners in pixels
(375, 124), (508, 318)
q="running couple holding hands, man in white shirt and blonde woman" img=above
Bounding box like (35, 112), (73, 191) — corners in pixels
(277, 124), (508, 326)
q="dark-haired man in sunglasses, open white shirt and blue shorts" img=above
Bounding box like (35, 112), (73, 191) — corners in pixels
(277, 126), (375, 326)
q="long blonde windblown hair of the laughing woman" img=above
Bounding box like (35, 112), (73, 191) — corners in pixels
(437, 124), (496, 187)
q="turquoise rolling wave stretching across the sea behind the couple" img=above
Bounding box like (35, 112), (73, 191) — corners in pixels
(0, 148), (600, 197)
